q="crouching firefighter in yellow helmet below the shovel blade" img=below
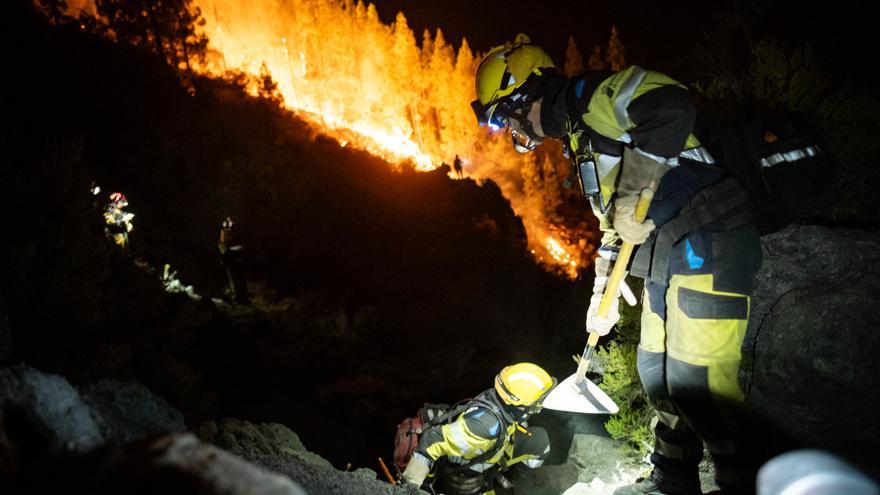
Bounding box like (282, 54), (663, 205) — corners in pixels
(402, 363), (556, 495)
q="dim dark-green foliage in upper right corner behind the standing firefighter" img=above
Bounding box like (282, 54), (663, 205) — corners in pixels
(695, 1), (880, 228)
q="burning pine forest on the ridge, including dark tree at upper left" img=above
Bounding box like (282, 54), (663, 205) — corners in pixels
(48, 0), (623, 277)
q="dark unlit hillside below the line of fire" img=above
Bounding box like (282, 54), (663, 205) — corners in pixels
(0, 2), (586, 465)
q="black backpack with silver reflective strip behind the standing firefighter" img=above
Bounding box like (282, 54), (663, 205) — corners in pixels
(697, 117), (840, 234)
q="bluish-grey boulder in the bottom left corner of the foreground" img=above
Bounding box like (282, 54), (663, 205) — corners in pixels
(0, 365), (185, 493)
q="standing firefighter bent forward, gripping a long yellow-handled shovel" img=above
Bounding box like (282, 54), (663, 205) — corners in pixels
(472, 35), (761, 495)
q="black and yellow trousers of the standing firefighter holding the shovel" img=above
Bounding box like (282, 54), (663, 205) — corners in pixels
(638, 227), (760, 493)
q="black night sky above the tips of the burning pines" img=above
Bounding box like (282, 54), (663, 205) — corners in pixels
(373, 0), (878, 80)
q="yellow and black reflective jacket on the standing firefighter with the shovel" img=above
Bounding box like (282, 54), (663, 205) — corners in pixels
(542, 66), (713, 245)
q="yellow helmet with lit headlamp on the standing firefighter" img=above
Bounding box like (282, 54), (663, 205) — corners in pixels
(471, 34), (555, 129)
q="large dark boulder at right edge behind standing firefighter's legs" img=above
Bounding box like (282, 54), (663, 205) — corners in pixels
(740, 226), (880, 473)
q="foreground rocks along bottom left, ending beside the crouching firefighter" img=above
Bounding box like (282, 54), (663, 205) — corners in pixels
(0, 366), (430, 495)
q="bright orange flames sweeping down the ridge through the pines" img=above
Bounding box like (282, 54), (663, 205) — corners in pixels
(195, 0), (587, 278)
